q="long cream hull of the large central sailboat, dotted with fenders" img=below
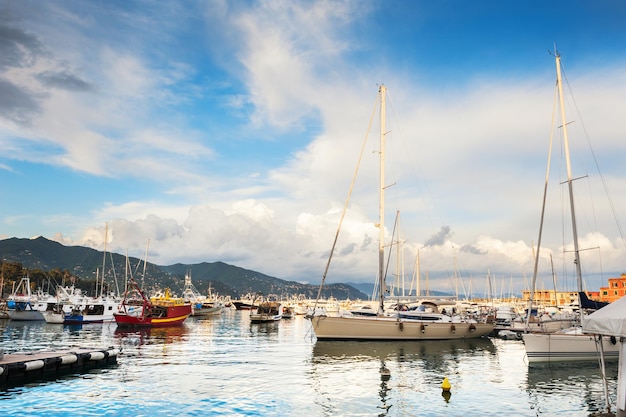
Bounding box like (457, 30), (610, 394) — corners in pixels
(311, 316), (495, 340)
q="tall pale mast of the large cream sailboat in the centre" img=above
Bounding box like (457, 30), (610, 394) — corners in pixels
(378, 85), (387, 313)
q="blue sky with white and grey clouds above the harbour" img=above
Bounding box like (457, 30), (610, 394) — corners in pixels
(0, 0), (626, 296)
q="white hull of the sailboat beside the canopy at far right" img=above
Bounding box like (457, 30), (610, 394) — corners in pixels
(522, 333), (619, 363)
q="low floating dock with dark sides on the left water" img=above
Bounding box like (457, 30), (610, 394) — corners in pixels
(0, 347), (121, 386)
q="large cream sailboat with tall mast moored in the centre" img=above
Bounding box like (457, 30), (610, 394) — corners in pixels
(307, 85), (495, 340)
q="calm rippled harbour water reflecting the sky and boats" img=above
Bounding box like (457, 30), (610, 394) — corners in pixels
(0, 311), (617, 417)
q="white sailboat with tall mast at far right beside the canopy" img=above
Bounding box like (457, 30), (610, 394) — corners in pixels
(522, 52), (619, 363)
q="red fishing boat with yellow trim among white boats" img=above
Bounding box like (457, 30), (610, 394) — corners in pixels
(113, 280), (192, 327)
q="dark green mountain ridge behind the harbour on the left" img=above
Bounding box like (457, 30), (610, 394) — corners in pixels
(0, 236), (367, 299)
